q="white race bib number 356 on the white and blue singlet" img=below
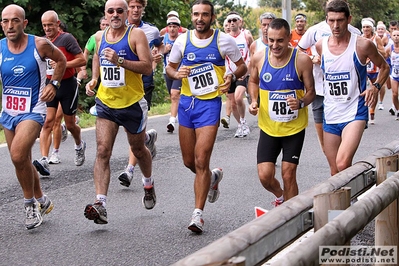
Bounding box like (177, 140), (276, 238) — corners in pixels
(324, 72), (351, 103)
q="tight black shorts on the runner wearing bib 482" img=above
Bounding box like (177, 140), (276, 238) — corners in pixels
(257, 129), (305, 164)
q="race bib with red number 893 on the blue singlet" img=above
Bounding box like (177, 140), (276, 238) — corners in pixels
(2, 86), (32, 116)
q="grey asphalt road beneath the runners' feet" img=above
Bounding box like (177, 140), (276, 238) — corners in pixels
(0, 91), (399, 265)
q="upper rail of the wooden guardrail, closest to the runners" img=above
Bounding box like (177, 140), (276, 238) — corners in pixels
(174, 140), (399, 266)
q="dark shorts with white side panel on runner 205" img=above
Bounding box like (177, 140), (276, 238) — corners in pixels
(96, 97), (148, 134)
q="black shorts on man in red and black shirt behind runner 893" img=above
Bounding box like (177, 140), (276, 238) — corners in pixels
(46, 76), (79, 115)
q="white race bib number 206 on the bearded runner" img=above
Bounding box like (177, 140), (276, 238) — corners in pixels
(187, 63), (219, 96)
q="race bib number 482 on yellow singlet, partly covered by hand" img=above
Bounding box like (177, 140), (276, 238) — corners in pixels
(269, 91), (298, 122)
